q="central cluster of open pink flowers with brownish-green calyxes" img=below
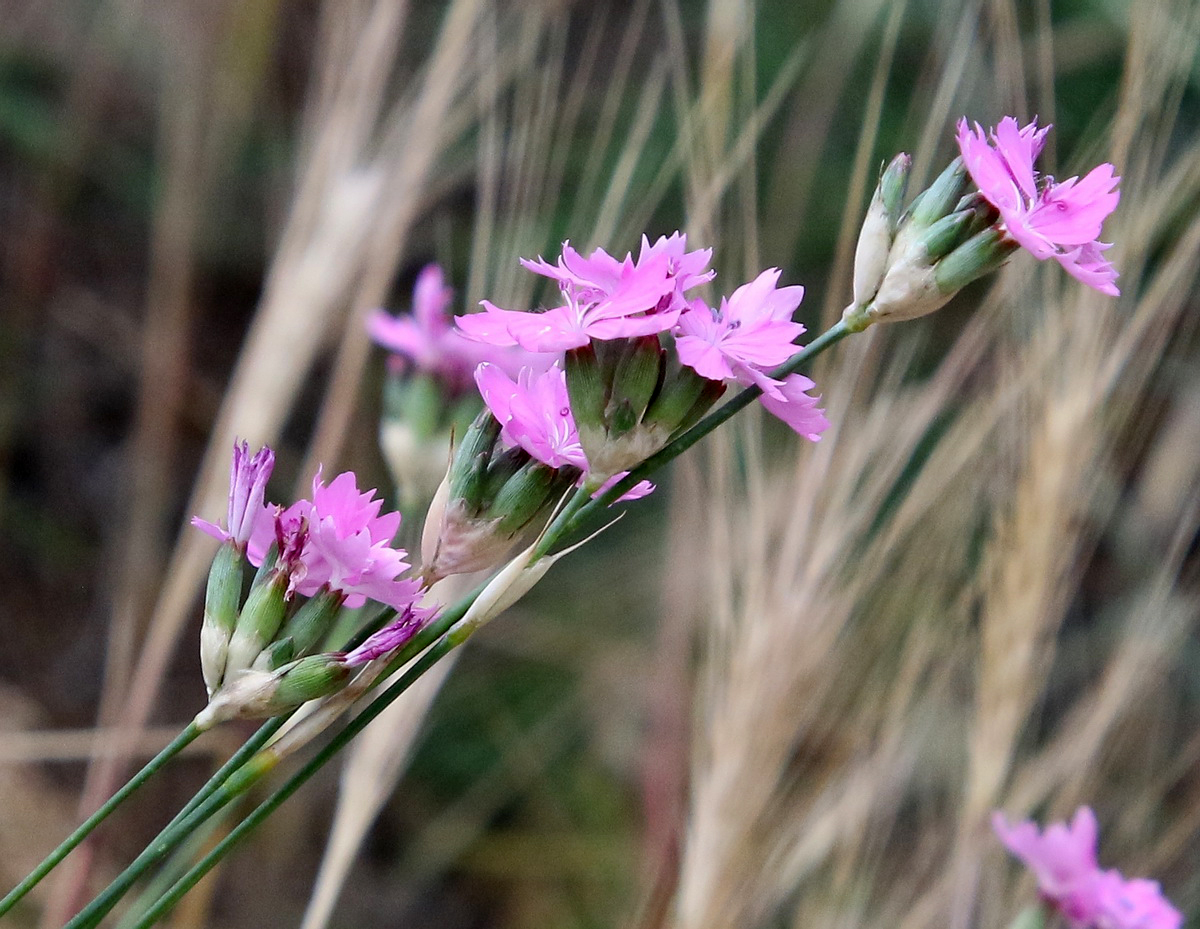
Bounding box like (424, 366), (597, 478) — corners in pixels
(457, 233), (828, 485)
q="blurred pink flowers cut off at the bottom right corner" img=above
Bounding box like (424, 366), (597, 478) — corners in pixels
(992, 807), (1183, 929)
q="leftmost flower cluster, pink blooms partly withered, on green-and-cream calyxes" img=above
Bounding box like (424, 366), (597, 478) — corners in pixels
(192, 442), (436, 723)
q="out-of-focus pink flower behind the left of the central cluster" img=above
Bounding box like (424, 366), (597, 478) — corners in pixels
(367, 264), (529, 391)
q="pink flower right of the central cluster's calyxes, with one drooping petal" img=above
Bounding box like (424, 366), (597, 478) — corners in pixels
(676, 268), (829, 442)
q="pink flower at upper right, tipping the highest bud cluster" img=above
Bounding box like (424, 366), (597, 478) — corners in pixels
(958, 116), (1121, 296)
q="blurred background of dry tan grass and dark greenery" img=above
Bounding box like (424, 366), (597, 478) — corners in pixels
(0, 0), (1200, 929)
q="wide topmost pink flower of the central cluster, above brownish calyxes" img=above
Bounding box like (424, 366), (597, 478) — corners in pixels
(458, 233), (713, 352)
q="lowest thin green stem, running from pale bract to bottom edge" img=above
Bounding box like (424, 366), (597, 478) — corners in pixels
(125, 639), (456, 929)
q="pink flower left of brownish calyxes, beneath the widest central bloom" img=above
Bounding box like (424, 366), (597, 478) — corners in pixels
(475, 364), (588, 471)
